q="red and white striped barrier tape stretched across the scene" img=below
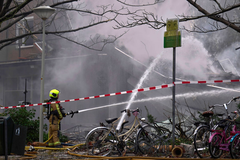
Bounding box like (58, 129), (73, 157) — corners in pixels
(0, 79), (240, 109)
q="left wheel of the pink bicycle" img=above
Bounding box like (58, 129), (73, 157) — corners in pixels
(209, 134), (224, 158)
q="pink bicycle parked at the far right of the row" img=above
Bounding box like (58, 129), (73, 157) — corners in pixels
(209, 97), (240, 158)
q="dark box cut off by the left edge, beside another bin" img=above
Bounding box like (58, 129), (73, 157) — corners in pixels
(0, 116), (14, 155)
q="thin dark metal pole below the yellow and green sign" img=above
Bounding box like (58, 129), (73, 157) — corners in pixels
(172, 47), (176, 147)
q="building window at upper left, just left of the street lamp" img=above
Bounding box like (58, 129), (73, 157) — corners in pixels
(16, 16), (33, 48)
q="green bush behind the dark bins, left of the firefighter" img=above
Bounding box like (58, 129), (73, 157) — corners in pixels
(1, 108), (47, 142)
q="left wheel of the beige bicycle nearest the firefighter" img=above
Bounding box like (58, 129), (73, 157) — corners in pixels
(86, 128), (116, 156)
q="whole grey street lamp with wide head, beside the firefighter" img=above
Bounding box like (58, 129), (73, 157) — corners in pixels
(33, 6), (55, 142)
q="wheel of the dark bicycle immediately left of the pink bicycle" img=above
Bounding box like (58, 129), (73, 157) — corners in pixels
(193, 126), (210, 158)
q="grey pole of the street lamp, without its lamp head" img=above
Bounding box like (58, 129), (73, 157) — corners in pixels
(39, 20), (45, 142)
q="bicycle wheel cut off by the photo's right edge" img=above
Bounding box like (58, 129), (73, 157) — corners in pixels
(230, 135), (240, 159)
